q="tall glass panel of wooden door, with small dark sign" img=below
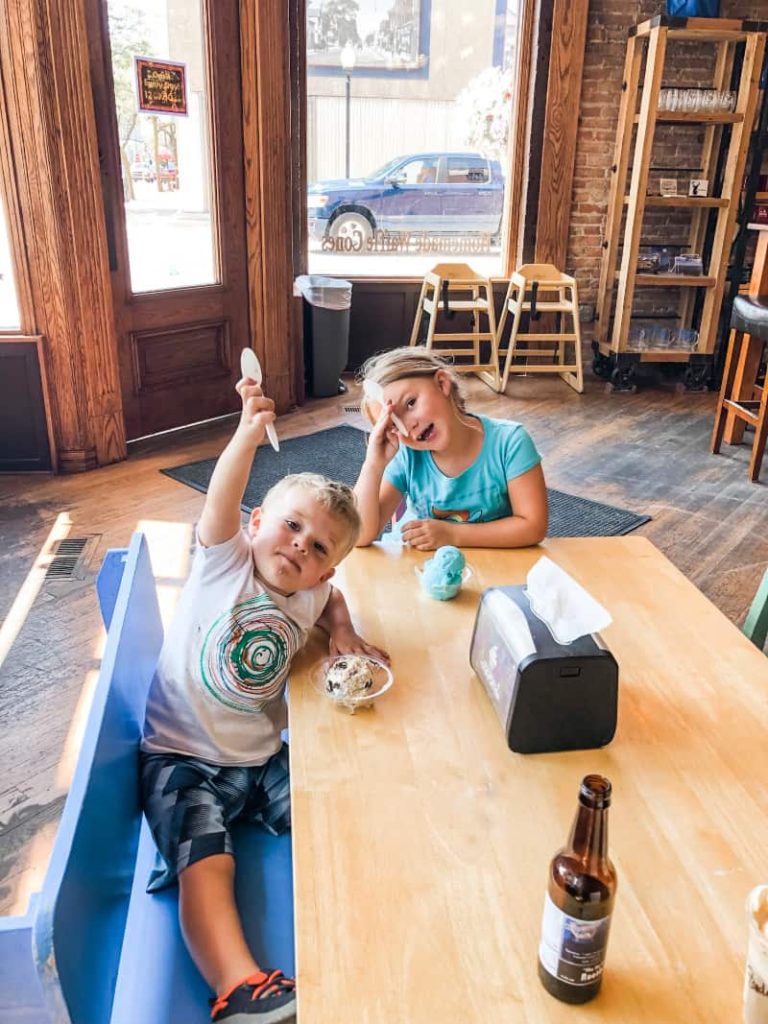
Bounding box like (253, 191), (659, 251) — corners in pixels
(108, 0), (220, 292)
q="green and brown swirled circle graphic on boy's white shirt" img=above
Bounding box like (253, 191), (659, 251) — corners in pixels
(200, 594), (302, 715)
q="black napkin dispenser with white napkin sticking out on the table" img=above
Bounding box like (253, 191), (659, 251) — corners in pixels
(469, 587), (618, 754)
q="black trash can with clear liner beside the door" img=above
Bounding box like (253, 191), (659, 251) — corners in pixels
(295, 273), (352, 398)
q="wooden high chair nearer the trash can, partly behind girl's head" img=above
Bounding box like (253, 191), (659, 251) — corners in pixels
(411, 263), (501, 391)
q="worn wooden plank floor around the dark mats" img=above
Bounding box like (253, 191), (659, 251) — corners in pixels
(0, 377), (768, 913)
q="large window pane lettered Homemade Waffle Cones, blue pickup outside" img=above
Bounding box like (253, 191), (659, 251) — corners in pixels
(306, 0), (520, 276)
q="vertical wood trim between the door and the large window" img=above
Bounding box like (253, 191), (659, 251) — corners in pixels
(240, 0), (300, 412)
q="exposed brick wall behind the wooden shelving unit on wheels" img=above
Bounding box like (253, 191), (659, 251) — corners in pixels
(567, 0), (768, 309)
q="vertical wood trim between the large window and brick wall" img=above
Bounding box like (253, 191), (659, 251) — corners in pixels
(535, 0), (589, 269)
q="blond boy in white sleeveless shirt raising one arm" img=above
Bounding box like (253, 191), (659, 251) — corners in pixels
(141, 380), (386, 1024)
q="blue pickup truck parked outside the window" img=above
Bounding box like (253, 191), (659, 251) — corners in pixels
(307, 153), (504, 249)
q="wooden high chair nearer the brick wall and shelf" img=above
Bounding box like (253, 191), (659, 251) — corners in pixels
(497, 263), (584, 394)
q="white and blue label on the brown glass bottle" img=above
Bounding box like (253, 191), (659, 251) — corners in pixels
(539, 893), (610, 985)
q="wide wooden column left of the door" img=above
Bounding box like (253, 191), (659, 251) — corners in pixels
(0, 0), (126, 472)
